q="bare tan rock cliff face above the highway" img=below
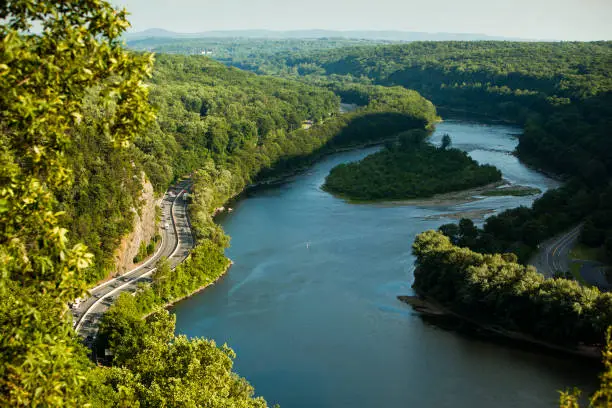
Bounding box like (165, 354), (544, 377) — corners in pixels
(115, 174), (161, 274)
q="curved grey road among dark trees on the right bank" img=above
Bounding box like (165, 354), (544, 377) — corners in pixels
(529, 224), (582, 278)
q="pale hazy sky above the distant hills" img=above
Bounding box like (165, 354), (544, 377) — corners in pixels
(111, 0), (612, 40)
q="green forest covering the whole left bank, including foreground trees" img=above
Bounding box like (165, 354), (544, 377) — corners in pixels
(0, 0), (437, 407)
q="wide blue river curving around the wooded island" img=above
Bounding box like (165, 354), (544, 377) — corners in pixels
(174, 121), (596, 408)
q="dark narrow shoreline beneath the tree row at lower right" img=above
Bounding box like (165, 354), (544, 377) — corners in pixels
(397, 296), (602, 360)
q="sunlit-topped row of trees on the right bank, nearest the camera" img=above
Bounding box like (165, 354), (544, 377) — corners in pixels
(413, 231), (612, 346)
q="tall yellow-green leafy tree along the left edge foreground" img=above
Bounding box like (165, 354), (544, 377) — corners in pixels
(0, 0), (153, 406)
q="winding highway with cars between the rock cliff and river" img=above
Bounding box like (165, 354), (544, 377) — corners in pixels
(72, 181), (194, 345)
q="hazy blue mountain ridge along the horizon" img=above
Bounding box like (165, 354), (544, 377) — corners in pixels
(124, 28), (542, 41)
